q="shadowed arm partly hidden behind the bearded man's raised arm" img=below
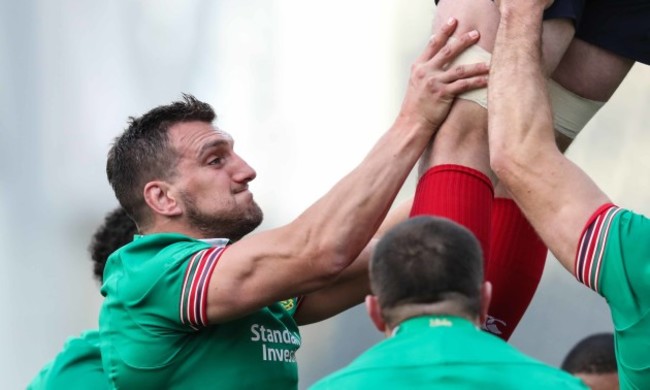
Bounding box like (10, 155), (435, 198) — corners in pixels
(293, 198), (413, 325)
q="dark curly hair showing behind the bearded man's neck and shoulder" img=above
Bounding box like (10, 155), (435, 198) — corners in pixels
(88, 207), (138, 283)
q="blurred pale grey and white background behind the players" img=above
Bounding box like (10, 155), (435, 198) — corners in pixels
(0, 0), (650, 389)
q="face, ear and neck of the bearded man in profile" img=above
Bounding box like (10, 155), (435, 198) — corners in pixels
(144, 125), (262, 238)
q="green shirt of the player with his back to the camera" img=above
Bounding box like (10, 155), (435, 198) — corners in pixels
(312, 316), (586, 390)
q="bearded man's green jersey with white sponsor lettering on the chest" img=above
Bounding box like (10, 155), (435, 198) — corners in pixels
(99, 233), (301, 389)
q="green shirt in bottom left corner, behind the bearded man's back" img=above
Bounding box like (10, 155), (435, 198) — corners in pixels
(27, 330), (108, 390)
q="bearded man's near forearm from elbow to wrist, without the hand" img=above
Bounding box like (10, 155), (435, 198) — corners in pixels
(295, 118), (434, 278)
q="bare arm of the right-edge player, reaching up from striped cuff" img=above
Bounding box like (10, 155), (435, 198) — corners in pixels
(488, 0), (609, 272)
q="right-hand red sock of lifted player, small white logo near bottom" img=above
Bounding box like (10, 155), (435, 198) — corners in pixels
(484, 198), (547, 340)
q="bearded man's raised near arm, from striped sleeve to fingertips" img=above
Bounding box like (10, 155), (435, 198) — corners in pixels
(207, 22), (487, 323)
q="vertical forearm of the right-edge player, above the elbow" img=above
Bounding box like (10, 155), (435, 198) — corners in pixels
(488, 2), (553, 168)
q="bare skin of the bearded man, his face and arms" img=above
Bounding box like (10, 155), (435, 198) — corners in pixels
(139, 21), (488, 324)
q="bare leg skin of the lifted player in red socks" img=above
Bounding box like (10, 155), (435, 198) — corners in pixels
(420, 0), (634, 186)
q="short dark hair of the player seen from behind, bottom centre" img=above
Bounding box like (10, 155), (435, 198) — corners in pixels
(370, 216), (483, 323)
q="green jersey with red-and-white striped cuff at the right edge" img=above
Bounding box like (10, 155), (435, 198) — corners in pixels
(574, 204), (650, 389)
